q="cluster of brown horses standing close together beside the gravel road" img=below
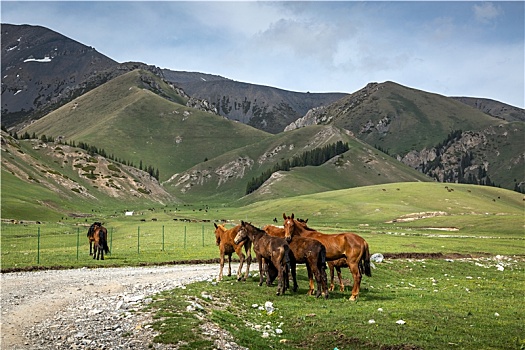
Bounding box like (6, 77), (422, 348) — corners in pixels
(214, 213), (372, 300)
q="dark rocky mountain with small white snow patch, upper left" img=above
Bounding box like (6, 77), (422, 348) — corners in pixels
(1, 24), (118, 126)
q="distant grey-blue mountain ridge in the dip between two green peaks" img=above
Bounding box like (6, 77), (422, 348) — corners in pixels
(162, 69), (347, 134)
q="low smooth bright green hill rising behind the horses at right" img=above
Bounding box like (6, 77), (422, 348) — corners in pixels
(236, 182), (525, 241)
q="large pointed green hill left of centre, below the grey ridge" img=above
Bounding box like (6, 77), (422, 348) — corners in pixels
(21, 70), (270, 180)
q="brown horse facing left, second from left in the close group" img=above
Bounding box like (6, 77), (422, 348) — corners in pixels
(234, 221), (290, 295)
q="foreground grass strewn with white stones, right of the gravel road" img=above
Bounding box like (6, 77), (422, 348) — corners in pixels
(144, 257), (525, 350)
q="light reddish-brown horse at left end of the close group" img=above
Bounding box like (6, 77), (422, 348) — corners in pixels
(213, 223), (252, 282)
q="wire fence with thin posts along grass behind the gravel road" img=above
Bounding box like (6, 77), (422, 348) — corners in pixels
(1, 223), (218, 269)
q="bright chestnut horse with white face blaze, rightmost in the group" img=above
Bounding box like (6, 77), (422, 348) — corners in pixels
(283, 213), (372, 300)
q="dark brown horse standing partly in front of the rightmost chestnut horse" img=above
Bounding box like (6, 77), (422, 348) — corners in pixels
(263, 225), (328, 298)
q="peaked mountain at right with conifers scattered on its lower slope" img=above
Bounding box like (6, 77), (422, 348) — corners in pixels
(285, 82), (525, 189)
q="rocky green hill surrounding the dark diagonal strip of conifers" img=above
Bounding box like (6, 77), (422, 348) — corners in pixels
(163, 126), (432, 204)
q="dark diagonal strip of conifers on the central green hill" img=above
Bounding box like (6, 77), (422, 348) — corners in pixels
(246, 141), (350, 194)
